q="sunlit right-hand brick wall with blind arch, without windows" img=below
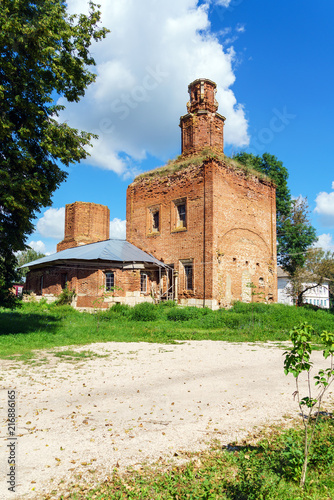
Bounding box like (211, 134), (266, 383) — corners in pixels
(213, 162), (277, 306)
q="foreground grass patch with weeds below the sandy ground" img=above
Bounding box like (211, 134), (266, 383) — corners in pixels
(46, 418), (334, 500)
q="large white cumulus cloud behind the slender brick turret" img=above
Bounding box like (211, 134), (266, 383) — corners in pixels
(60, 0), (249, 175)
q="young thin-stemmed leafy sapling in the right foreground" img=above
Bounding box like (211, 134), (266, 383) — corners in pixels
(284, 322), (334, 488)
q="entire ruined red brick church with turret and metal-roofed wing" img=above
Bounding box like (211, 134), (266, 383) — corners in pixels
(26, 78), (277, 309)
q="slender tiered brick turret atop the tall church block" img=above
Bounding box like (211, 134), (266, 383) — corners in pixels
(180, 78), (225, 156)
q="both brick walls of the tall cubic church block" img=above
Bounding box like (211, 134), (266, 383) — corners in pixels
(127, 160), (276, 306)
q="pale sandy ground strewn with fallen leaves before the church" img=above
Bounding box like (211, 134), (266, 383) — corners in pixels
(0, 341), (332, 499)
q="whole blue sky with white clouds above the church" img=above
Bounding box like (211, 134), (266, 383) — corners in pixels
(27, 0), (334, 253)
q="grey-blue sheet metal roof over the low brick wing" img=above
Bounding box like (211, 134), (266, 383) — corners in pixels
(21, 239), (168, 268)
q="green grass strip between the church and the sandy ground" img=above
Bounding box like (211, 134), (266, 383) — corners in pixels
(0, 303), (334, 359)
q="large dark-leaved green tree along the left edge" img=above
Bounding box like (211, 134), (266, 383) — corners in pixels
(0, 0), (108, 304)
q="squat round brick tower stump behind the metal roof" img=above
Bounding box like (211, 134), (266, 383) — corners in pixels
(57, 201), (110, 252)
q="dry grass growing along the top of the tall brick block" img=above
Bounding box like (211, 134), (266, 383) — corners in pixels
(134, 148), (272, 186)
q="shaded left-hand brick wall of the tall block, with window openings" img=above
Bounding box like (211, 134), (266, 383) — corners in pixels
(126, 166), (210, 297)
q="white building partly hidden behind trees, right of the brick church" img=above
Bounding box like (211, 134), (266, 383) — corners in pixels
(277, 266), (329, 309)
